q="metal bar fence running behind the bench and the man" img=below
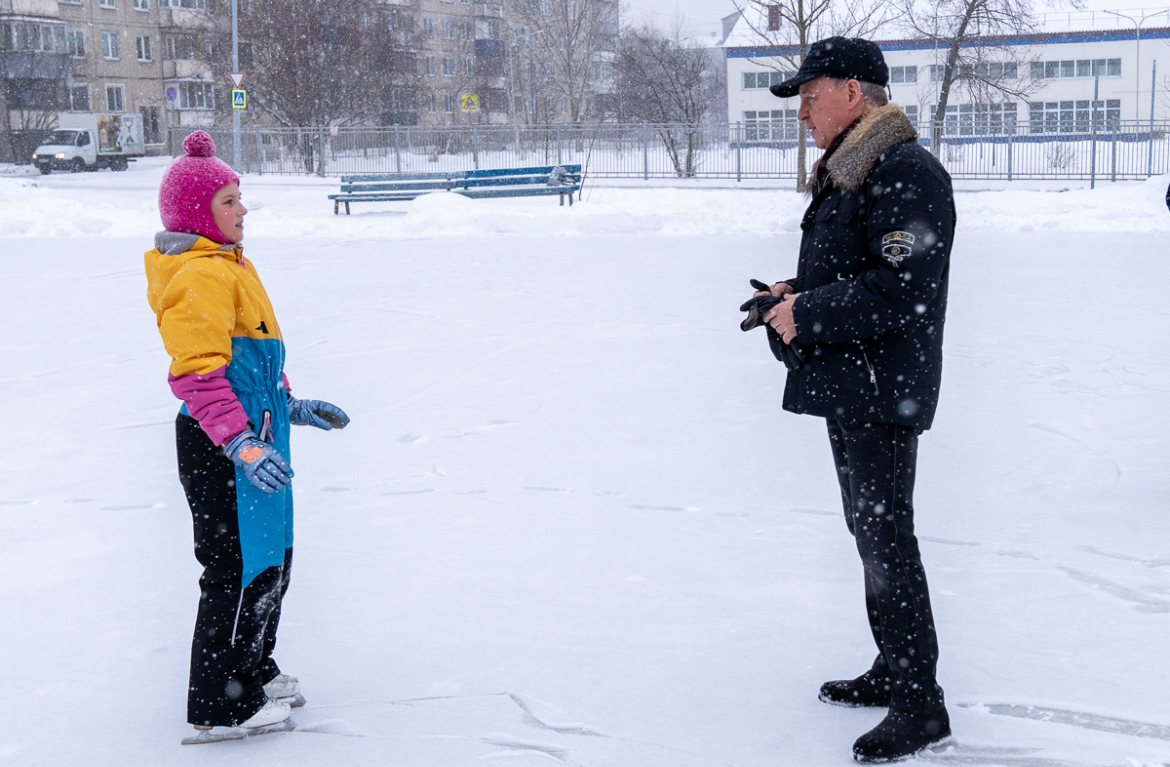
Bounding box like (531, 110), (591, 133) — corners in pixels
(172, 119), (1170, 180)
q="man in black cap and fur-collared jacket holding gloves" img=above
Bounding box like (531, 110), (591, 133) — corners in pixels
(756, 37), (955, 761)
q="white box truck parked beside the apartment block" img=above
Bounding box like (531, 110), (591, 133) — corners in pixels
(33, 115), (146, 173)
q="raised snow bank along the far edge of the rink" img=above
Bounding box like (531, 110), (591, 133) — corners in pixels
(0, 158), (1170, 240)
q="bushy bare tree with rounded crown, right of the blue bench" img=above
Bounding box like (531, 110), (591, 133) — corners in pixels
(617, 25), (724, 177)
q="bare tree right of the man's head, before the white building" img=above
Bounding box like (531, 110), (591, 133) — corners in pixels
(902, 0), (1053, 154)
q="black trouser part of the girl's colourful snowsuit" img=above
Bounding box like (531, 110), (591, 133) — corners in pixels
(176, 414), (293, 726)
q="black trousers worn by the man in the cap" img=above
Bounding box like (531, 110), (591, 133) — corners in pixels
(828, 420), (943, 714)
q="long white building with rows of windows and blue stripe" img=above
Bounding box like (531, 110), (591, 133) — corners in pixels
(722, 8), (1170, 140)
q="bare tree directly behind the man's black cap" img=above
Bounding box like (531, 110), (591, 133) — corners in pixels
(734, 0), (884, 192)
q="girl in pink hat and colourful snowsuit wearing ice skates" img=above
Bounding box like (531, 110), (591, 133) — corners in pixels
(146, 131), (349, 742)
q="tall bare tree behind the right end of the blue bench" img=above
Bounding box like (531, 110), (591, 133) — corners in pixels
(509, 0), (618, 123)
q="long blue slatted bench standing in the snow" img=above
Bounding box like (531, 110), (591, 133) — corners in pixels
(329, 165), (581, 215)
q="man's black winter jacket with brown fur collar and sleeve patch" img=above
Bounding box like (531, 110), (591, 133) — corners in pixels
(784, 104), (955, 429)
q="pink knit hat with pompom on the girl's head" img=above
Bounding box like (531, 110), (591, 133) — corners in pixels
(158, 131), (240, 244)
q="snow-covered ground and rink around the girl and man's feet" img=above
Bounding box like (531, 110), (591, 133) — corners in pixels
(0, 161), (1170, 767)
